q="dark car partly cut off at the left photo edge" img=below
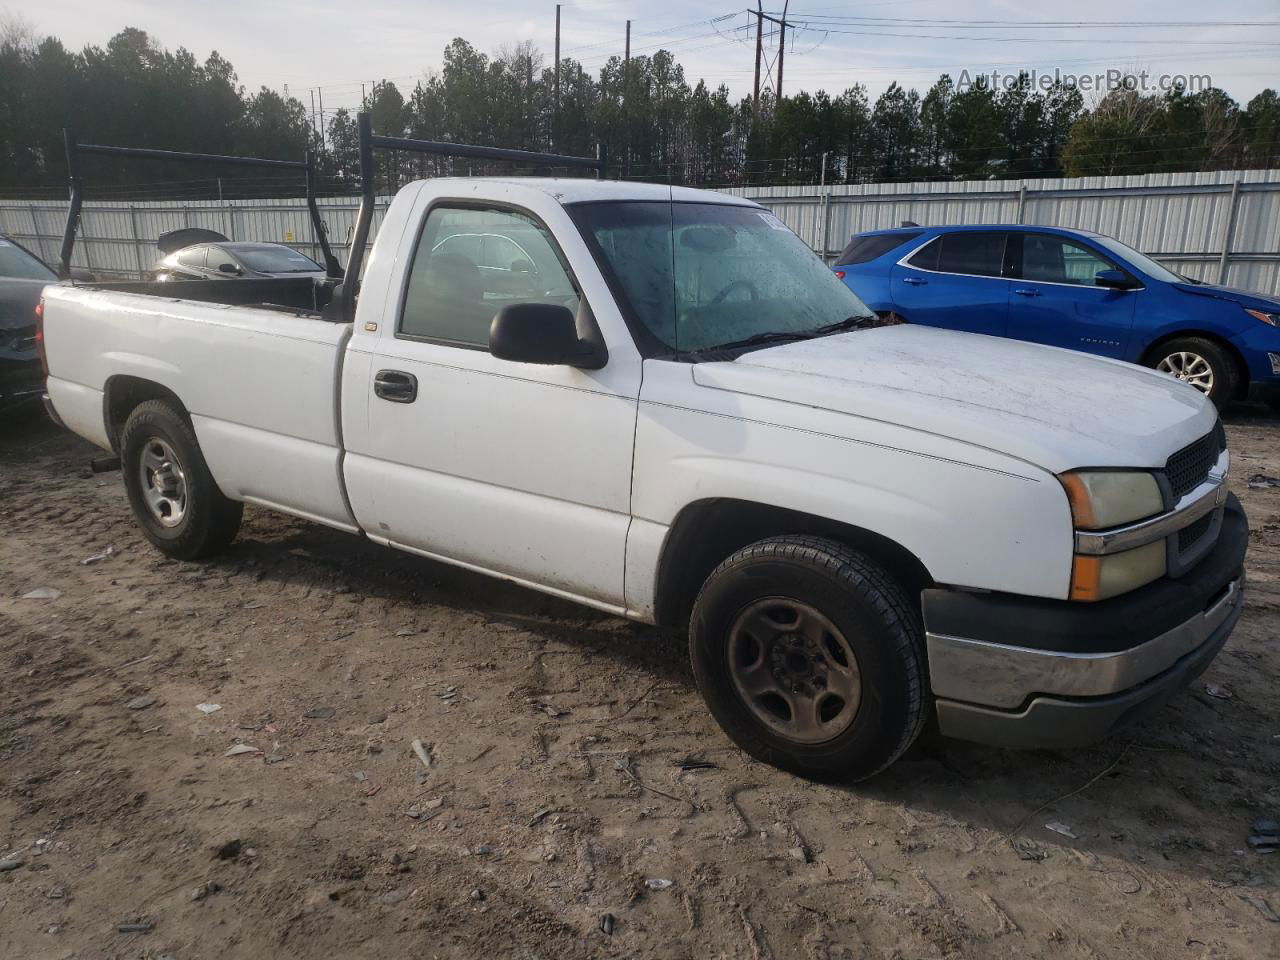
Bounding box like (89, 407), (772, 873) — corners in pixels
(0, 234), (58, 410)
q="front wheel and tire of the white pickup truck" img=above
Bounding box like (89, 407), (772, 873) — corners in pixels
(689, 536), (929, 780)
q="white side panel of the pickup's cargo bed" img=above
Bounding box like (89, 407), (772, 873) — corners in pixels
(45, 279), (355, 530)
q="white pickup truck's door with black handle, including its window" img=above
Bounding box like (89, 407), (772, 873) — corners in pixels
(344, 200), (640, 608)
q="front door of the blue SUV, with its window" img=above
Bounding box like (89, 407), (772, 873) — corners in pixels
(1009, 230), (1142, 357)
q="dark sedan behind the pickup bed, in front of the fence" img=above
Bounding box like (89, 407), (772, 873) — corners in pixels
(156, 229), (325, 280)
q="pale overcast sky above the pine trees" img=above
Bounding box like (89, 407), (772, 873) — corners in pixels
(10, 0), (1280, 113)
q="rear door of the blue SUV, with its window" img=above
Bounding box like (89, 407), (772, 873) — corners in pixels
(891, 230), (1009, 337)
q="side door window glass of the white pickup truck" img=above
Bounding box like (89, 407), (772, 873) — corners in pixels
(397, 206), (580, 347)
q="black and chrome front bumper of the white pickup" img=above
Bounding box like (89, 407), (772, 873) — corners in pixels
(923, 497), (1249, 748)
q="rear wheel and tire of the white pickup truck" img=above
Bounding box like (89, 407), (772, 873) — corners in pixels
(120, 401), (244, 561)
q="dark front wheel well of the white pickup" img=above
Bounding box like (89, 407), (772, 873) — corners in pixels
(655, 499), (933, 627)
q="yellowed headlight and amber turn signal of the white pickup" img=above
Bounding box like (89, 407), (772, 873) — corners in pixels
(1059, 470), (1167, 602)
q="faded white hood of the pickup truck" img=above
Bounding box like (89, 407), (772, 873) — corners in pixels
(694, 324), (1217, 474)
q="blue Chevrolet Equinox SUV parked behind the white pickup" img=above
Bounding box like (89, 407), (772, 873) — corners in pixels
(833, 225), (1280, 408)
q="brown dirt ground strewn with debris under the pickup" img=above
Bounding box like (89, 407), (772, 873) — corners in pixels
(0, 411), (1280, 960)
